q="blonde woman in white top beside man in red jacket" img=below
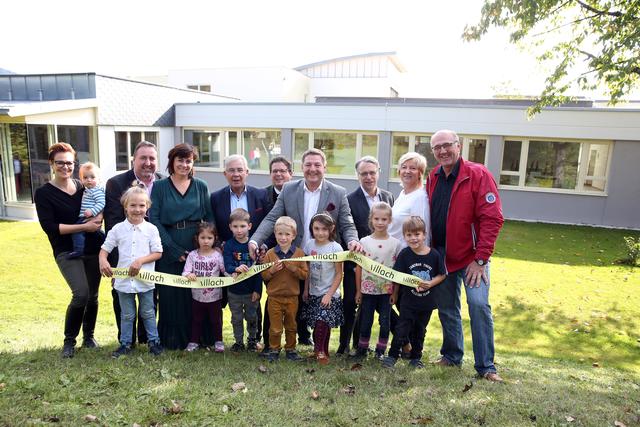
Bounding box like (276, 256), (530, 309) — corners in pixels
(389, 151), (431, 247)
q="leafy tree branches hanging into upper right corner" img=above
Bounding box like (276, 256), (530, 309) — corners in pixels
(462, 0), (640, 116)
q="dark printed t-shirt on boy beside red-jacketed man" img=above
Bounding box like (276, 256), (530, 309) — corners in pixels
(393, 247), (446, 309)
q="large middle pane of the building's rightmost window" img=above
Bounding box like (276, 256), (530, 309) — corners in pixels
(525, 141), (580, 190)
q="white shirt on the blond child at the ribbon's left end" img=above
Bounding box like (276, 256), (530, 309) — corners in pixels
(102, 219), (162, 294)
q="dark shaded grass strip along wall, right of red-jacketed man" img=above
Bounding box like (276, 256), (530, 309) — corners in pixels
(494, 221), (640, 271)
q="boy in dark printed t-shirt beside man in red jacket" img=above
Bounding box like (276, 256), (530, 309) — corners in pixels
(382, 216), (446, 368)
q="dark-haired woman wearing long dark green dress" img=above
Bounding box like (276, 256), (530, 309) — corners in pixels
(149, 144), (213, 350)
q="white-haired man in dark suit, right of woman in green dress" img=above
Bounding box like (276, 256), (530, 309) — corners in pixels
(211, 154), (272, 350)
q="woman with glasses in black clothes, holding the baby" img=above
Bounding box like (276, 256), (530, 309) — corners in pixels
(35, 142), (102, 358)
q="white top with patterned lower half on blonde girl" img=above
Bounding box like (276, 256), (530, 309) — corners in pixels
(360, 236), (402, 295)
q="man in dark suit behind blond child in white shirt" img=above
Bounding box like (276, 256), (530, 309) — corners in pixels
(104, 141), (162, 345)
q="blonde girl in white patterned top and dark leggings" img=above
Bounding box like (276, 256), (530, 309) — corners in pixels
(355, 202), (402, 359)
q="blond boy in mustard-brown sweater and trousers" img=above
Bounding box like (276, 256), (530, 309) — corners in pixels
(262, 216), (309, 362)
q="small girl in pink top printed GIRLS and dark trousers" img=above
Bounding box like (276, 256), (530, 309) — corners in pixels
(182, 222), (224, 353)
